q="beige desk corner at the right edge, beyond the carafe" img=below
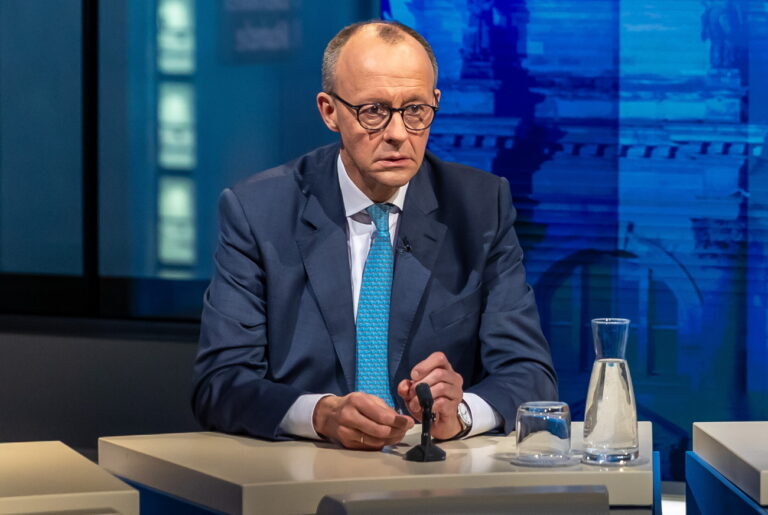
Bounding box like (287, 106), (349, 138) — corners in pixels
(693, 422), (768, 507)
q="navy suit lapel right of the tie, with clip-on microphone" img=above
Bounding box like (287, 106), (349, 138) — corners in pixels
(389, 160), (446, 379)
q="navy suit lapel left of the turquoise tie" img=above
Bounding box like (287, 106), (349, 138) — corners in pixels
(296, 148), (356, 392)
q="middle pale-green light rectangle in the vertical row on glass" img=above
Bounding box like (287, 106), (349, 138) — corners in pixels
(157, 82), (197, 170)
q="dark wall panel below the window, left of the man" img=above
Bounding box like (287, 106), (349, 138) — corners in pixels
(0, 324), (199, 453)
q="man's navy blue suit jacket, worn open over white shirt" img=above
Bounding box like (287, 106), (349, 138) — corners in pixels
(192, 145), (557, 438)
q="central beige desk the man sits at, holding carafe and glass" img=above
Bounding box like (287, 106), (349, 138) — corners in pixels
(99, 422), (653, 514)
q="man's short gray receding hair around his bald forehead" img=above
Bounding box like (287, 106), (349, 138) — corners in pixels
(323, 20), (437, 92)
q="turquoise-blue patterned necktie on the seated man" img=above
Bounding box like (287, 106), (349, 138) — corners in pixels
(355, 204), (395, 408)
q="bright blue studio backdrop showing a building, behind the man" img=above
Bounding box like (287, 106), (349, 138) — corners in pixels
(382, 0), (768, 480)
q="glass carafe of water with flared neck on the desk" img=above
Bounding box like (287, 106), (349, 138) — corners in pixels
(583, 318), (638, 464)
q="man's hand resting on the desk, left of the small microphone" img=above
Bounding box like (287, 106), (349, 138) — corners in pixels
(312, 392), (413, 451)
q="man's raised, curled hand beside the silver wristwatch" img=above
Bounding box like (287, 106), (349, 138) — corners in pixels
(397, 352), (464, 440)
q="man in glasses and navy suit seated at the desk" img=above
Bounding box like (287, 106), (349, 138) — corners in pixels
(193, 21), (557, 449)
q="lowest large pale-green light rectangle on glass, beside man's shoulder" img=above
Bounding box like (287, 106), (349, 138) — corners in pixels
(157, 176), (196, 266)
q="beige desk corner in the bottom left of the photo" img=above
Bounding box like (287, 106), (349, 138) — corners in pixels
(0, 442), (139, 515)
